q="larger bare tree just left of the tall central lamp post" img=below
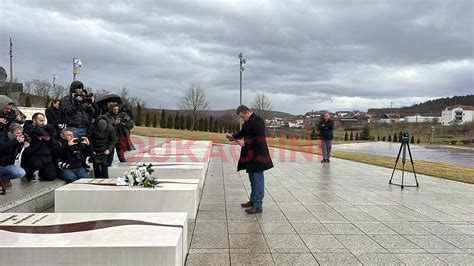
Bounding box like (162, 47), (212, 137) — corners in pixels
(179, 83), (209, 130)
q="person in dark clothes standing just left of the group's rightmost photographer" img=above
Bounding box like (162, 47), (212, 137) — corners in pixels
(87, 116), (117, 178)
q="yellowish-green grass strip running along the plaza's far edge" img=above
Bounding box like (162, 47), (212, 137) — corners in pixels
(132, 127), (474, 184)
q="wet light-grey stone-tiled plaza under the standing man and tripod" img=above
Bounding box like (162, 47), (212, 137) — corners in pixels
(187, 145), (474, 265)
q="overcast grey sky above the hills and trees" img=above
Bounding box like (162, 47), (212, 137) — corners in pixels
(0, 0), (474, 114)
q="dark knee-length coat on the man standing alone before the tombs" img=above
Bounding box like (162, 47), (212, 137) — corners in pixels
(233, 113), (273, 173)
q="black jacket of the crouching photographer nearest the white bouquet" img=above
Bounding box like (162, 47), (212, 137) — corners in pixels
(55, 140), (93, 169)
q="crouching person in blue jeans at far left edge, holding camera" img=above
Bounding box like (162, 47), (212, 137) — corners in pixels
(0, 123), (30, 192)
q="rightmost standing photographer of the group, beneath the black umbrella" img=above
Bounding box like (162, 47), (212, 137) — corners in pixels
(105, 103), (135, 166)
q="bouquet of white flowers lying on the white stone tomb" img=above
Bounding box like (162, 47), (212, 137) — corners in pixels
(117, 164), (158, 188)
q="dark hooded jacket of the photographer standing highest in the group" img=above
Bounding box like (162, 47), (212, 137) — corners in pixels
(61, 81), (95, 128)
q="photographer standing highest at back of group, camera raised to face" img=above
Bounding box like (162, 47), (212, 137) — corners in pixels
(60, 81), (95, 138)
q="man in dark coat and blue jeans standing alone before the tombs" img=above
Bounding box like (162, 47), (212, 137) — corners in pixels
(226, 105), (273, 214)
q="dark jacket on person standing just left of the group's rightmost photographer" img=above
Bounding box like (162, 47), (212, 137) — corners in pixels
(87, 116), (117, 154)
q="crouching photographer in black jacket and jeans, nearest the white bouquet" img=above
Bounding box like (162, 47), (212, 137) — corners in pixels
(57, 128), (93, 183)
